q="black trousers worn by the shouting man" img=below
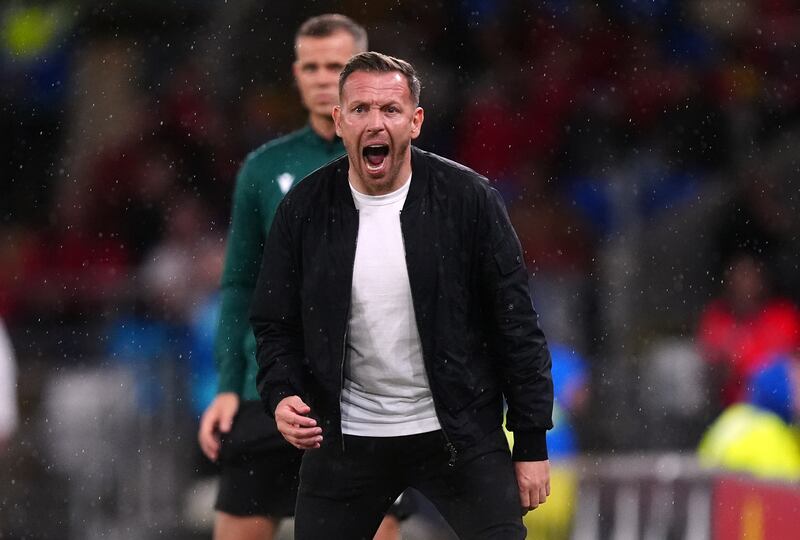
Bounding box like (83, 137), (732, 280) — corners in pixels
(295, 430), (526, 540)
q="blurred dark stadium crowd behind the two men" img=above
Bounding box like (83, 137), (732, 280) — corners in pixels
(0, 0), (800, 538)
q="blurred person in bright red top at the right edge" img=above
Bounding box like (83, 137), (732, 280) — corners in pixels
(697, 254), (800, 405)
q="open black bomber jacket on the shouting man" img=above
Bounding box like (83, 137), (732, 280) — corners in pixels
(250, 147), (553, 461)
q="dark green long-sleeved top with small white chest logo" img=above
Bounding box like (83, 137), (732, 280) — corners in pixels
(214, 126), (344, 400)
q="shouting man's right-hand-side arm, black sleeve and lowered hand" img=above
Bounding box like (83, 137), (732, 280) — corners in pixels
(480, 189), (553, 510)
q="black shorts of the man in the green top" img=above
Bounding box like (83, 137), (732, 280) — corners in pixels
(214, 401), (303, 518)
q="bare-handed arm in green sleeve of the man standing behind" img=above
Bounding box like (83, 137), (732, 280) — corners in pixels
(198, 161), (263, 461)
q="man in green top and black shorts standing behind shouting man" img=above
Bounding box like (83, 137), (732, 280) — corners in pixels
(198, 14), (399, 540)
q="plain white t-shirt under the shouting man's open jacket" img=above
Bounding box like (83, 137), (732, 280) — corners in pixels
(341, 176), (441, 437)
